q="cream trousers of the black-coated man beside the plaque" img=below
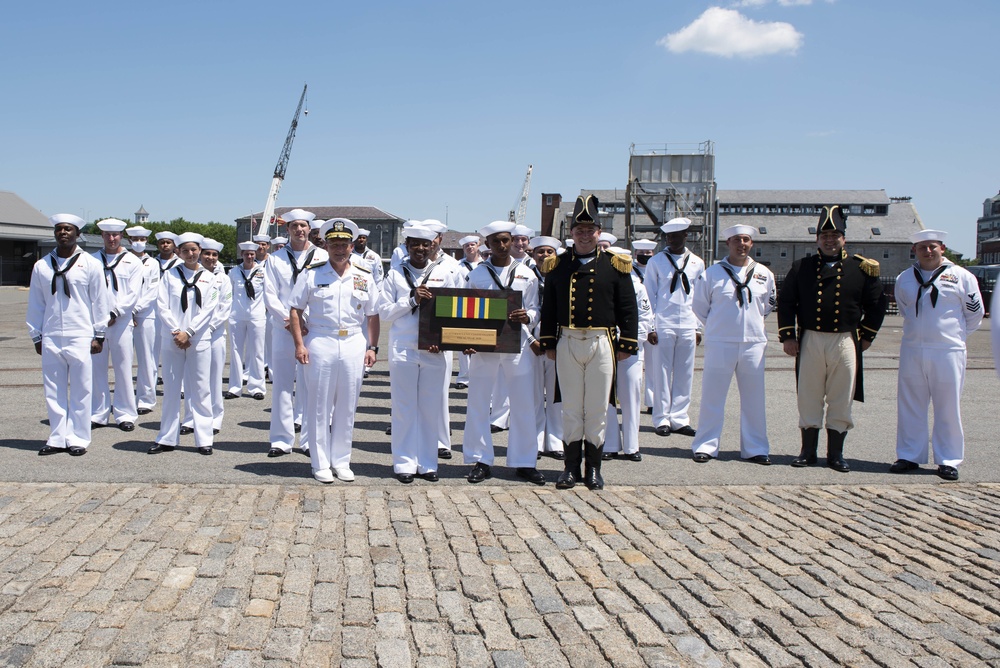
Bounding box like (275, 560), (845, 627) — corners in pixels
(556, 328), (615, 446)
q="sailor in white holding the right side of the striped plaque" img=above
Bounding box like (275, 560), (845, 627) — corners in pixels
(462, 221), (545, 485)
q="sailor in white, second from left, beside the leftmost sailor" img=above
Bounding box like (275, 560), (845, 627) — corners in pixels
(90, 218), (145, 431)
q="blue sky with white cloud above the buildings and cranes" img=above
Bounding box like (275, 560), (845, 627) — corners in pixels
(0, 0), (1000, 254)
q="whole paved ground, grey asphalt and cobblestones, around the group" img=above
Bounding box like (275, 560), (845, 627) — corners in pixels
(0, 288), (1000, 666)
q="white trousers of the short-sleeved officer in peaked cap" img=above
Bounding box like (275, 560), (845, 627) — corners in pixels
(308, 329), (368, 472)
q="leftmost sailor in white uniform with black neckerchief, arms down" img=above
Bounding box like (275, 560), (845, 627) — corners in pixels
(26, 213), (111, 456)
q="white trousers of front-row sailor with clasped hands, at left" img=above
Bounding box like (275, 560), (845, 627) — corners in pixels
(156, 342), (213, 448)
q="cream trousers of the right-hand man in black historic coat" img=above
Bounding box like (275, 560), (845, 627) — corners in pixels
(798, 329), (857, 431)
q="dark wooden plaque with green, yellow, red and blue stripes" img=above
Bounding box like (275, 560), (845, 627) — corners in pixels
(417, 288), (524, 353)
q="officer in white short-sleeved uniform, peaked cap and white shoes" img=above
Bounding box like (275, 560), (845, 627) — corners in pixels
(292, 219), (382, 483)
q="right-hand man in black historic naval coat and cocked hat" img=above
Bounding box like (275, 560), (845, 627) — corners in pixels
(778, 206), (886, 473)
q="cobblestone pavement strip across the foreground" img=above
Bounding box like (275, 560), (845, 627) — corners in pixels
(0, 482), (1000, 667)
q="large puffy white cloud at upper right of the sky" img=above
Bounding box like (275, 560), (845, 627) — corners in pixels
(657, 6), (803, 58)
